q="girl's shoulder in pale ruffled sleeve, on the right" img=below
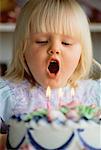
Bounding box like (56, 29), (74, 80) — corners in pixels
(78, 79), (101, 105)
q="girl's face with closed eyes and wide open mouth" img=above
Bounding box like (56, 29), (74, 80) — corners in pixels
(25, 33), (81, 88)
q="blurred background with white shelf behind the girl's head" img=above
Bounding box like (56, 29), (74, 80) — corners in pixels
(0, 0), (101, 76)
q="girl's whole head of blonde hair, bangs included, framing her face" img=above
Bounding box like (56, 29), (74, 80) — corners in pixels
(6, 0), (92, 85)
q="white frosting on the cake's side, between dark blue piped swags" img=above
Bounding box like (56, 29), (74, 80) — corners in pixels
(6, 110), (101, 150)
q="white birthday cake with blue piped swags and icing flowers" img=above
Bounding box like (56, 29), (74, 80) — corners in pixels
(7, 105), (101, 150)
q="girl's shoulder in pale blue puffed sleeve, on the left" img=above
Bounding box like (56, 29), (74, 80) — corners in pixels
(0, 78), (30, 120)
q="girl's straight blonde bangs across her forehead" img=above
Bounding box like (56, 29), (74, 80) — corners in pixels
(31, 1), (79, 38)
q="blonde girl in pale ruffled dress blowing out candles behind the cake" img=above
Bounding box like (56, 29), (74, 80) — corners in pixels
(0, 0), (100, 147)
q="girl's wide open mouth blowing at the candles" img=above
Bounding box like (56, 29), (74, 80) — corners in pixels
(48, 59), (59, 77)
